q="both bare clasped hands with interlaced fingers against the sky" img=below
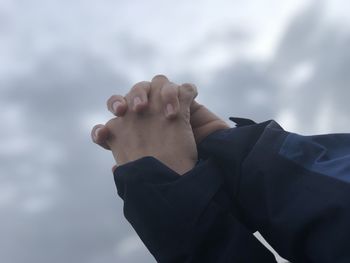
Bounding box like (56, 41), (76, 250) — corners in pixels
(91, 75), (229, 174)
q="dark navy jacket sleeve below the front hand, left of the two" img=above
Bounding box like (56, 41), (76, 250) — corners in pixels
(114, 157), (275, 263)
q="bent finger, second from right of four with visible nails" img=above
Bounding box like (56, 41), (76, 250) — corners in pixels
(126, 81), (151, 112)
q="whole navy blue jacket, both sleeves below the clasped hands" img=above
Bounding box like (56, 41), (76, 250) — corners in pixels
(114, 118), (350, 263)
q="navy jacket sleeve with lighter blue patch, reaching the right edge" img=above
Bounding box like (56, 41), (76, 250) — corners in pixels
(199, 121), (350, 262)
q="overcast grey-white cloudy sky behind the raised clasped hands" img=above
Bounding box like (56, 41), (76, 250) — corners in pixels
(0, 0), (350, 263)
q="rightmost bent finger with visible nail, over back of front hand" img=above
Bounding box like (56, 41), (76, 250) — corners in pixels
(160, 82), (180, 119)
